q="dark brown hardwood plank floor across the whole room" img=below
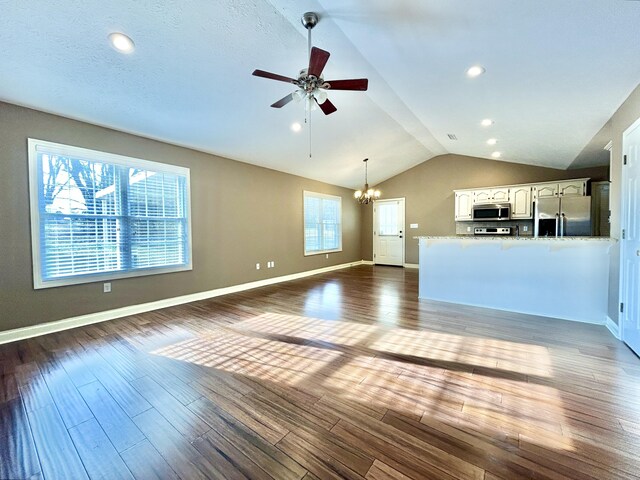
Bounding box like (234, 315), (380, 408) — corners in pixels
(0, 266), (640, 480)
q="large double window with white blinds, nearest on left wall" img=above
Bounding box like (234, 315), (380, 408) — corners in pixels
(29, 139), (191, 288)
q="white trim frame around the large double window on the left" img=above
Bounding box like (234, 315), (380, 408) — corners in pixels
(28, 138), (193, 290)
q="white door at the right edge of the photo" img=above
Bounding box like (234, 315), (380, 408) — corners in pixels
(620, 119), (640, 355)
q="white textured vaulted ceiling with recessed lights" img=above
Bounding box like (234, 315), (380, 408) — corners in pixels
(0, 0), (640, 187)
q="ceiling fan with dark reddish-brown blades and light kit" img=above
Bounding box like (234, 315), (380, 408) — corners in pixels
(253, 12), (369, 115)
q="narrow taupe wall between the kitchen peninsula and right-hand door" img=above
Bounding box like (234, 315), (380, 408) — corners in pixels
(609, 85), (640, 323)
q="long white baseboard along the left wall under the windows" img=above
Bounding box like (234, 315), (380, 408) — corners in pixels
(0, 260), (373, 345)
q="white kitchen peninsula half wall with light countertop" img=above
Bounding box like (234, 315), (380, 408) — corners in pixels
(417, 236), (613, 324)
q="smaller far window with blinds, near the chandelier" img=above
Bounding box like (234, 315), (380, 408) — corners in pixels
(304, 191), (342, 255)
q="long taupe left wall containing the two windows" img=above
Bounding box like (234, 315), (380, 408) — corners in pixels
(0, 103), (362, 331)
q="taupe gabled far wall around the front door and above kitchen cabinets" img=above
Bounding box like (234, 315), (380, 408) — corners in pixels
(362, 155), (608, 264)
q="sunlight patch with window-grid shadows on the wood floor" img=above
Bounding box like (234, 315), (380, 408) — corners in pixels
(151, 313), (573, 450)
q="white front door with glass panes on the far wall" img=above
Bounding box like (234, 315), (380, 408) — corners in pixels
(373, 198), (405, 266)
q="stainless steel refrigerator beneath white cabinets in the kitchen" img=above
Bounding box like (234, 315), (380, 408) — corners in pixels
(534, 197), (591, 237)
